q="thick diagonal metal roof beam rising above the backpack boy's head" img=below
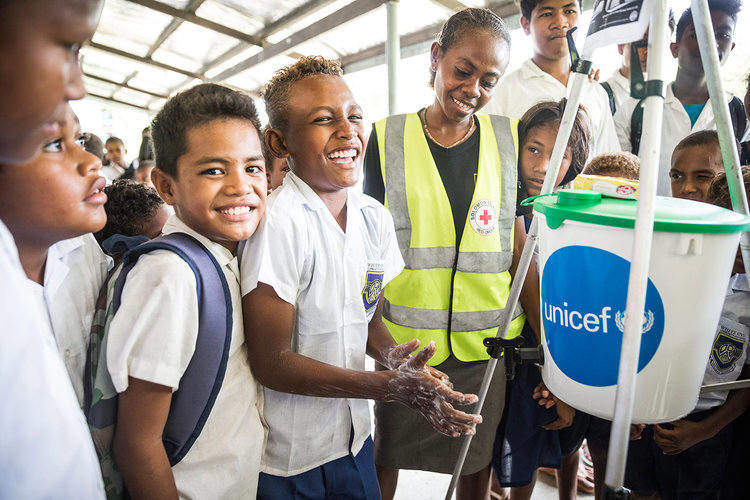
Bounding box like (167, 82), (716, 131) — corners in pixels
(214, 0), (387, 81)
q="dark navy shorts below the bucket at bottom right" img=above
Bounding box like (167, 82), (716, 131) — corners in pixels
(625, 410), (733, 500)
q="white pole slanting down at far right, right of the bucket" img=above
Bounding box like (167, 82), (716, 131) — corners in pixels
(690, 0), (750, 276)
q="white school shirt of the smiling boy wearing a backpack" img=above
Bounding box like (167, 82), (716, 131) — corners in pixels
(107, 215), (265, 499)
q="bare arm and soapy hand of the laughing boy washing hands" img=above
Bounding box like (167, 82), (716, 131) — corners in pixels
(242, 282), (481, 437)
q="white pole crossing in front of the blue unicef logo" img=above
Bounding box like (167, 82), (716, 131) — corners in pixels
(605, 0), (668, 490)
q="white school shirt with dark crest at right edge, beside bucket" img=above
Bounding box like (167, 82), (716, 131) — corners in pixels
(695, 274), (750, 411)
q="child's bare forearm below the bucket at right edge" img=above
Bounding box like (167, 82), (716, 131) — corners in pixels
(654, 365), (750, 455)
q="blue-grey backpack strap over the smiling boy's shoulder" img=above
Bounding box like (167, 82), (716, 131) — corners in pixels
(113, 233), (232, 466)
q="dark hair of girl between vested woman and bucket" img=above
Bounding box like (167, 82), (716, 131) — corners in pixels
(518, 99), (591, 184)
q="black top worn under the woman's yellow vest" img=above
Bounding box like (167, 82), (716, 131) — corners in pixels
(364, 118), (479, 246)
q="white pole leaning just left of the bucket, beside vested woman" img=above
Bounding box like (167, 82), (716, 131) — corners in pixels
(445, 50), (593, 500)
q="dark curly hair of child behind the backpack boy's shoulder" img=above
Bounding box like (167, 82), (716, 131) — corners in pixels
(94, 179), (164, 245)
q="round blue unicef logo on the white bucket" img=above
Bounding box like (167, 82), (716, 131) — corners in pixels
(542, 245), (664, 387)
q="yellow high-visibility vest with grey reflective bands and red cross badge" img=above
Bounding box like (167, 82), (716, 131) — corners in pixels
(375, 113), (525, 365)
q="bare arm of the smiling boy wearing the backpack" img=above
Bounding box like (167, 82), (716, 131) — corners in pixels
(113, 377), (177, 499)
